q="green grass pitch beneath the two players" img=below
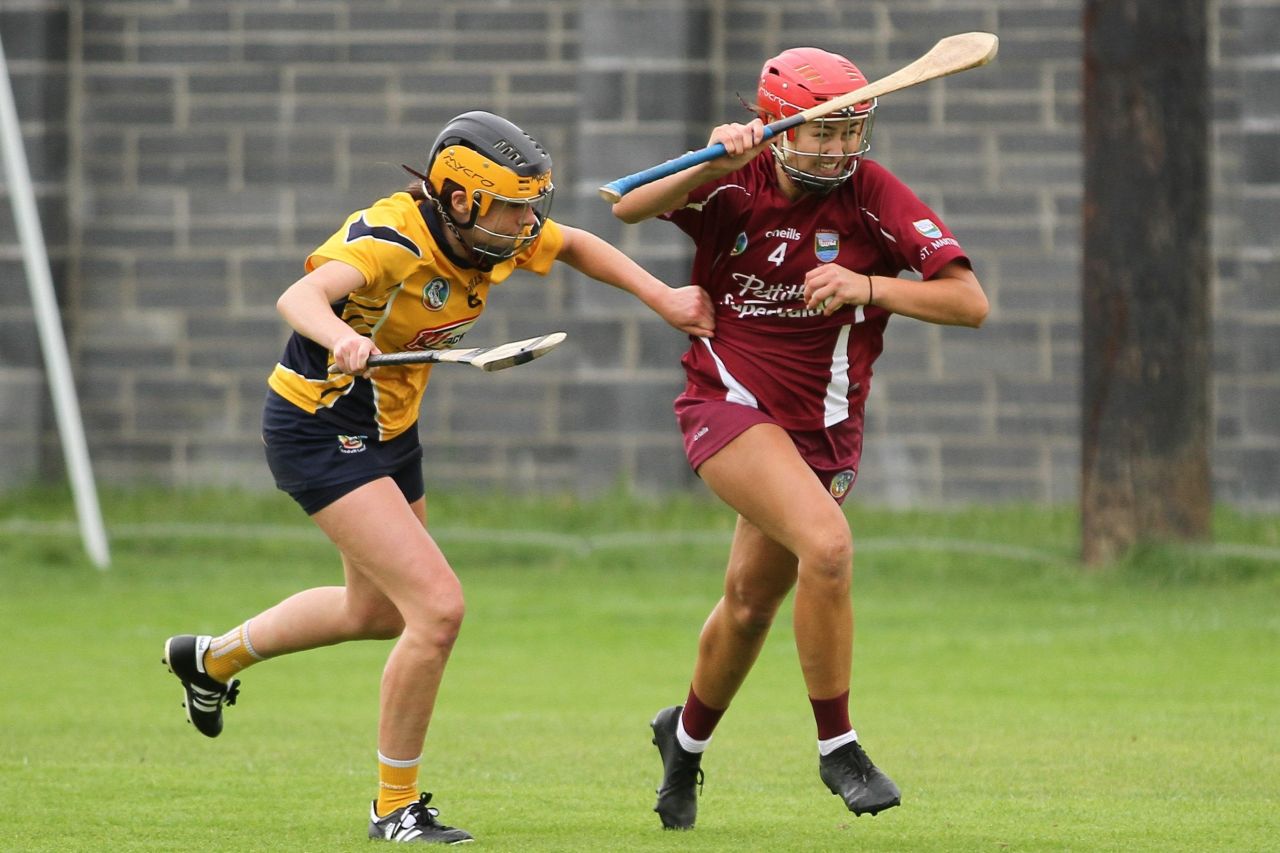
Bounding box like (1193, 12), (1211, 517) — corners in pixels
(0, 484), (1280, 853)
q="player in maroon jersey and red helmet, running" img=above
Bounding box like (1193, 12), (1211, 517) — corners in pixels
(613, 47), (987, 829)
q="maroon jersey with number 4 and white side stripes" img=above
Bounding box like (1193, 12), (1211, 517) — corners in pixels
(663, 150), (965, 430)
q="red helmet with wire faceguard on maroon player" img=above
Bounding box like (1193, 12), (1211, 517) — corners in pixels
(756, 47), (876, 192)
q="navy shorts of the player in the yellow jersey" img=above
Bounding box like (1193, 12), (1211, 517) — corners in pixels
(262, 391), (426, 515)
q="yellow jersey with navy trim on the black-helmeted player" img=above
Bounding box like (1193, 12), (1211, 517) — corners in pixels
(268, 192), (564, 441)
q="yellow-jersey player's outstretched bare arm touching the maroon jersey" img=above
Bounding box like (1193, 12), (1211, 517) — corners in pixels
(557, 225), (716, 338)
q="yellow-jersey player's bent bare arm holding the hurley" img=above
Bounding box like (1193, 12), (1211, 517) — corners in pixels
(275, 260), (380, 374)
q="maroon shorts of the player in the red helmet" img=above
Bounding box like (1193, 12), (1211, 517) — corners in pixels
(676, 394), (863, 503)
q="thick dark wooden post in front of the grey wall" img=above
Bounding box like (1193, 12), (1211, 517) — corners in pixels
(1080, 0), (1212, 565)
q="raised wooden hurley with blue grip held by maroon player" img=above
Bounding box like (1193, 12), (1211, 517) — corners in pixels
(600, 32), (1000, 204)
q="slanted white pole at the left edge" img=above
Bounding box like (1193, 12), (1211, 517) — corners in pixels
(0, 31), (111, 569)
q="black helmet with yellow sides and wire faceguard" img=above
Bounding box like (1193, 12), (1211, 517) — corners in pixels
(426, 110), (556, 264)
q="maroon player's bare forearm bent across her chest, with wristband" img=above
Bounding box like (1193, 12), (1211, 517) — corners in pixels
(804, 261), (989, 328)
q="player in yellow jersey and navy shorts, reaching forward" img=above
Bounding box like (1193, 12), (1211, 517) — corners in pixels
(164, 111), (713, 844)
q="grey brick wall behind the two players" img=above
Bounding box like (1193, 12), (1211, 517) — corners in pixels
(0, 0), (1280, 507)
